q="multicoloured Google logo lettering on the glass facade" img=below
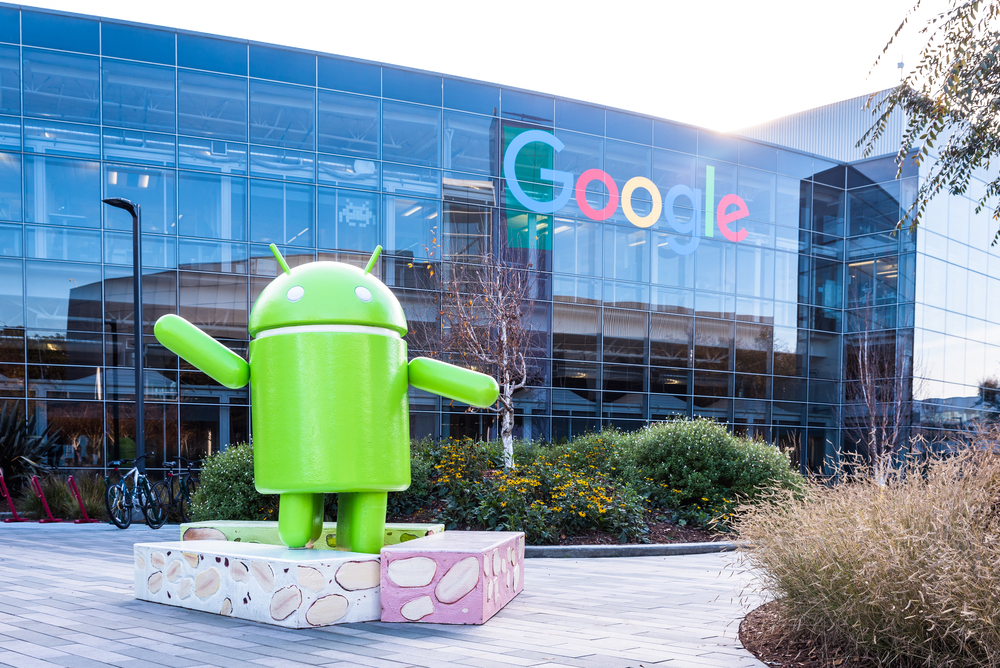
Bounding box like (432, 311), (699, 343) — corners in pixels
(503, 130), (750, 255)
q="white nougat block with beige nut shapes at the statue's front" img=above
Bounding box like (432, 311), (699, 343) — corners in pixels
(134, 540), (382, 629)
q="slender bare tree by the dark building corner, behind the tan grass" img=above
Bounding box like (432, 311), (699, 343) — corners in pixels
(844, 298), (914, 481)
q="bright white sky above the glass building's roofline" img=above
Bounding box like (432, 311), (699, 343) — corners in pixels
(19, 0), (950, 131)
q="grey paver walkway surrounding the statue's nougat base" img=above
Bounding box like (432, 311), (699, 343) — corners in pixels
(0, 524), (764, 668)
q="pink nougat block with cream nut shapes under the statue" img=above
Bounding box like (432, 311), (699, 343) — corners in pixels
(382, 531), (524, 624)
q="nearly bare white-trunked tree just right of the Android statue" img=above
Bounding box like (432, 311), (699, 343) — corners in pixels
(410, 253), (537, 468)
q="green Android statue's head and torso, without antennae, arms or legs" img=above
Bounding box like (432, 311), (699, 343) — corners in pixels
(249, 263), (410, 493)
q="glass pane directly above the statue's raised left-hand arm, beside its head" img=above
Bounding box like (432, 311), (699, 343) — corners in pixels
(178, 271), (247, 339)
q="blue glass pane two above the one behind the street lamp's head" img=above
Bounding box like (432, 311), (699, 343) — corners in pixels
(102, 60), (176, 132)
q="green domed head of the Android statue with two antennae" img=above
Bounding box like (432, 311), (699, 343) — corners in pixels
(249, 244), (406, 338)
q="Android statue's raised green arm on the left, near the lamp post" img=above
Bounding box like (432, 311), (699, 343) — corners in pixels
(153, 314), (250, 390)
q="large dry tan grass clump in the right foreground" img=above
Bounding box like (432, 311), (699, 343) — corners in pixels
(735, 448), (1000, 667)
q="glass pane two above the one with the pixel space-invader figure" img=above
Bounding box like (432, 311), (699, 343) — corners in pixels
(318, 90), (379, 158)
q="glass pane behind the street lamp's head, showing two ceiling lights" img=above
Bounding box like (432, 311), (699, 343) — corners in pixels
(104, 165), (177, 234)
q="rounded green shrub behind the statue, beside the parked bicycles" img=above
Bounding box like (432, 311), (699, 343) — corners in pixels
(191, 443), (278, 522)
